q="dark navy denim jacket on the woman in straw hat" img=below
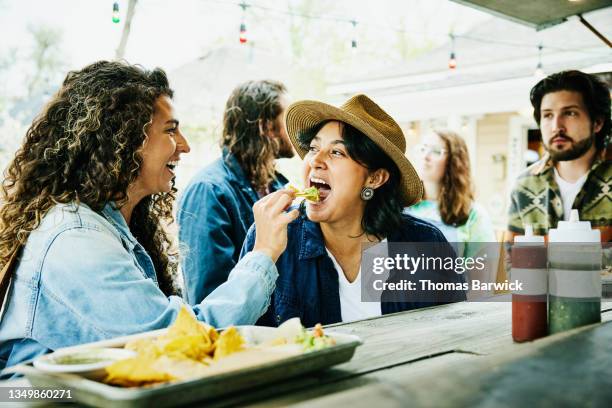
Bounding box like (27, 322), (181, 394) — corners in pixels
(241, 210), (465, 327)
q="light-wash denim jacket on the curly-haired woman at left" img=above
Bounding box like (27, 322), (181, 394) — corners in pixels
(0, 204), (278, 368)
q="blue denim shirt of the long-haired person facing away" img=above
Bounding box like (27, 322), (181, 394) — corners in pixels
(177, 149), (287, 304)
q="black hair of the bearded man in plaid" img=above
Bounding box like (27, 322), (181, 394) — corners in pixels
(530, 70), (612, 150)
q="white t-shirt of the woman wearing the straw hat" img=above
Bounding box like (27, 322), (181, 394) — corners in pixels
(325, 239), (387, 322)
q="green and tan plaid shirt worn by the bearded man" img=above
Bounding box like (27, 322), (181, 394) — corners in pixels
(508, 152), (612, 242)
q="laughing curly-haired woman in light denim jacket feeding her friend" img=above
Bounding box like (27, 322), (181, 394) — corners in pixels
(0, 62), (297, 367)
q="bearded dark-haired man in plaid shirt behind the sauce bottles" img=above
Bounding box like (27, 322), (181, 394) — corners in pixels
(507, 71), (612, 242)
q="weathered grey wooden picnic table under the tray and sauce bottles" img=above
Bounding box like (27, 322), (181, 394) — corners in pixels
(1, 296), (612, 408)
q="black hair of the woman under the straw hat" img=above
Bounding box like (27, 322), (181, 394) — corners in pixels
(298, 121), (402, 240)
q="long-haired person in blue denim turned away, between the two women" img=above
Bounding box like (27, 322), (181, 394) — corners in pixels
(177, 81), (294, 304)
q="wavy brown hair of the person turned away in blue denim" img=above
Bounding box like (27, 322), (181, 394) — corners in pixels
(220, 81), (287, 191)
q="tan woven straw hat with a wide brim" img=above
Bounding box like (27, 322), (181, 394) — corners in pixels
(286, 95), (423, 205)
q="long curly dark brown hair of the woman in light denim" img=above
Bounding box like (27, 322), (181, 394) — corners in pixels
(0, 61), (179, 295)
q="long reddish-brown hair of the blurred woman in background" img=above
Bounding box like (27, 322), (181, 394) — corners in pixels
(434, 129), (474, 226)
